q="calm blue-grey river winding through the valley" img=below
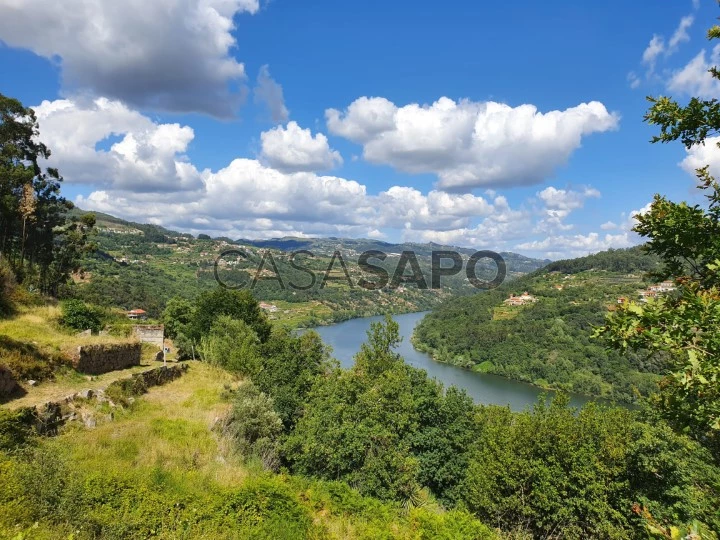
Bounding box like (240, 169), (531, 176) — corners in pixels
(314, 312), (612, 411)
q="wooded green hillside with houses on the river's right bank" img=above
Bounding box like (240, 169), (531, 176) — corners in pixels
(414, 248), (666, 401)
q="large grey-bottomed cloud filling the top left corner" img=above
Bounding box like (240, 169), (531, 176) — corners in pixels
(0, 0), (260, 116)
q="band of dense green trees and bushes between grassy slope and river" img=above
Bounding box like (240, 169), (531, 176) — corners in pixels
(163, 298), (720, 538)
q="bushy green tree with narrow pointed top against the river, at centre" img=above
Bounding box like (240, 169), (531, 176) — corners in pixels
(285, 317), (420, 501)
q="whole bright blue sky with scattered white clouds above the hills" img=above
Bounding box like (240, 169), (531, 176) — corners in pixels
(0, 0), (720, 259)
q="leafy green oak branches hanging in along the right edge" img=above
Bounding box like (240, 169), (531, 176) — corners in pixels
(598, 19), (720, 459)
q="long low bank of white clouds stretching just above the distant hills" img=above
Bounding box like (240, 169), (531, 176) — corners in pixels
(35, 98), (636, 256)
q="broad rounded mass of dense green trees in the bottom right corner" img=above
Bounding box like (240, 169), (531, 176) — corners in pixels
(460, 396), (720, 538)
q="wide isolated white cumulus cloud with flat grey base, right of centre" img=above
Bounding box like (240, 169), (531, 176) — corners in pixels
(325, 97), (619, 190)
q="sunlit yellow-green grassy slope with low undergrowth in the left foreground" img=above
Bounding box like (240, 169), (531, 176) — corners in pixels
(0, 364), (495, 540)
